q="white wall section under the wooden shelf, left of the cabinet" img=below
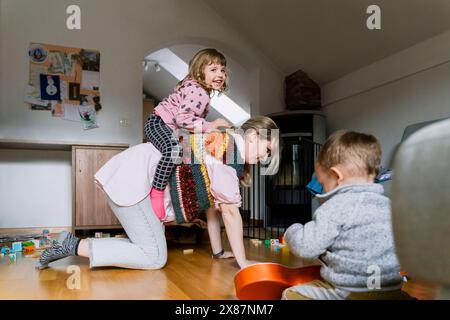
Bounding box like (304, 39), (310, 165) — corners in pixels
(0, 149), (72, 228)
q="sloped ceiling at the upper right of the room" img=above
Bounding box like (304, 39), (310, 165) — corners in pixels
(204, 0), (450, 85)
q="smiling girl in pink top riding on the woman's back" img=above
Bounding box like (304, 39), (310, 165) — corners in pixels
(145, 48), (230, 220)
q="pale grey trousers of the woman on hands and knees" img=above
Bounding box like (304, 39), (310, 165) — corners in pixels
(89, 196), (167, 269)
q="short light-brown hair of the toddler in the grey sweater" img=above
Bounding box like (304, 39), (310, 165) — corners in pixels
(317, 130), (381, 176)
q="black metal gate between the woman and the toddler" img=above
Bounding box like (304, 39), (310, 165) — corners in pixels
(241, 136), (321, 239)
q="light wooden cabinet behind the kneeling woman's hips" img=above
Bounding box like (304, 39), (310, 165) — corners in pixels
(72, 146), (126, 230)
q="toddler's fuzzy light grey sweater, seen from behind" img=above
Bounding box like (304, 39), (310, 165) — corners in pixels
(285, 183), (402, 291)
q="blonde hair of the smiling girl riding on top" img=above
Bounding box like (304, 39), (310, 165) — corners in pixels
(178, 48), (228, 94)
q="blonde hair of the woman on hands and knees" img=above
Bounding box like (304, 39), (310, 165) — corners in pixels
(240, 116), (280, 187)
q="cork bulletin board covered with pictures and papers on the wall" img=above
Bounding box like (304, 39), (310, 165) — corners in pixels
(24, 43), (102, 129)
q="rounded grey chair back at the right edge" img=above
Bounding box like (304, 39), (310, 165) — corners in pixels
(391, 119), (450, 299)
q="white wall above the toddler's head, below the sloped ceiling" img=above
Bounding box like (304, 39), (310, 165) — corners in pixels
(322, 31), (450, 166)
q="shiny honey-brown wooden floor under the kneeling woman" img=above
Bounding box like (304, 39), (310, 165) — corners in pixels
(0, 232), (436, 300)
